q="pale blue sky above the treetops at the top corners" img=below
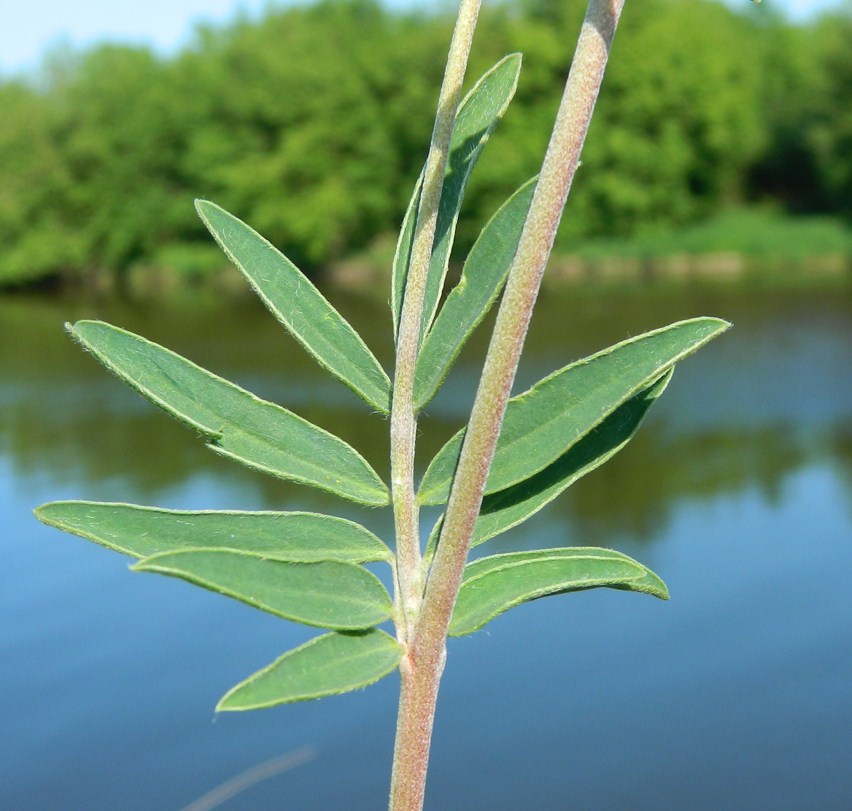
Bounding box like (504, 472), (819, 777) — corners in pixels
(0, 0), (842, 75)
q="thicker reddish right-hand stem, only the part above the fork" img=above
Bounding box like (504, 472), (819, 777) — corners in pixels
(422, 0), (624, 650)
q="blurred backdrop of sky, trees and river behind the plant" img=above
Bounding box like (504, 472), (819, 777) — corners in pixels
(0, 0), (852, 811)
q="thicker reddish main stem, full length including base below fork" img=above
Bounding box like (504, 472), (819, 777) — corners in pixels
(391, 0), (624, 811)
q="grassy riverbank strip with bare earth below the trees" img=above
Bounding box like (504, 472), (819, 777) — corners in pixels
(5, 208), (852, 298)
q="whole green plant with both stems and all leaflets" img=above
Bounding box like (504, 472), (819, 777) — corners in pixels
(36, 0), (729, 811)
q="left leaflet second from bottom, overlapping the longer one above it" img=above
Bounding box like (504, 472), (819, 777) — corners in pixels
(131, 549), (393, 630)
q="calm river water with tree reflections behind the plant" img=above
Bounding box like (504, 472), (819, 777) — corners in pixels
(0, 287), (852, 811)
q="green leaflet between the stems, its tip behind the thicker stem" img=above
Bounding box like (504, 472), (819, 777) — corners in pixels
(414, 178), (537, 409)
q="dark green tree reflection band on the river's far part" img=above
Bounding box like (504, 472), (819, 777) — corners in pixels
(0, 286), (852, 544)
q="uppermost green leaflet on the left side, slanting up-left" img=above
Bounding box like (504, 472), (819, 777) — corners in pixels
(195, 200), (390, 414)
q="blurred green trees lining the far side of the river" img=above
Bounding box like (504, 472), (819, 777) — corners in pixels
(0, 0), (852, 285)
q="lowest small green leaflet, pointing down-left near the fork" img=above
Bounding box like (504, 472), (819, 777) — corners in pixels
(216, 628), (402, 710)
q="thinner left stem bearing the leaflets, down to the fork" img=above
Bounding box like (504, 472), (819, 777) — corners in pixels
(390, 0), (480, 644)
